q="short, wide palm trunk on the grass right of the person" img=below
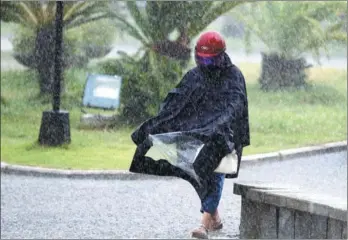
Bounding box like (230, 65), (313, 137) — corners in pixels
(259, 53), (310, 91)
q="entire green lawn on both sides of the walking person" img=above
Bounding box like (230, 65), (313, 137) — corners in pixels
(1, 64), (347, 169)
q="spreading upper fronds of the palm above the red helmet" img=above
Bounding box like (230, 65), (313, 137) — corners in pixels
(114, 0), (248, 44)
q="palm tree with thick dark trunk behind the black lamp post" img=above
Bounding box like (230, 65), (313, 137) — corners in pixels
(1, 1), (115, 94)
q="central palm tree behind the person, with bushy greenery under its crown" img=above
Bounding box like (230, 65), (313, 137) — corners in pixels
(102, 0), (246, 124)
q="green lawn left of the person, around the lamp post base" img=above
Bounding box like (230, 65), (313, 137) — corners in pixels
(1, 68), (135, 169)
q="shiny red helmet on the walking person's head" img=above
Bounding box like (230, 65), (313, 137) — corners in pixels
(195, 31), (226, 57)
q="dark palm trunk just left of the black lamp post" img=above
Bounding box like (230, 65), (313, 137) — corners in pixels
(34, 25), (63, 95)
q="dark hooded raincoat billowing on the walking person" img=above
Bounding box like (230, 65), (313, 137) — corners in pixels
(129, 54), (250, 199)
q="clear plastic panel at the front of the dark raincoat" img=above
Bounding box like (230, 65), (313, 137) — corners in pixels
(146, 132), (204, 182)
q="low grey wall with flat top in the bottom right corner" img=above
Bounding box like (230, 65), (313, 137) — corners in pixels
(234, 183), (347, 239)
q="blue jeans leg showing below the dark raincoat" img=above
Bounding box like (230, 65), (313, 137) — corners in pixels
(201, 173), (225, 214)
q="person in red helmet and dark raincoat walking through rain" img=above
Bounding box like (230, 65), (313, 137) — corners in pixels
(129, 31), (250, 239)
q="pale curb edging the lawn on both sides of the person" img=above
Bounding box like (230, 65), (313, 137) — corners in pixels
(1, 141), (347, 180)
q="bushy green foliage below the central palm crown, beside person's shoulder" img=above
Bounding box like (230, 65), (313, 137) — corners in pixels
(98, 55), (181, 124)
